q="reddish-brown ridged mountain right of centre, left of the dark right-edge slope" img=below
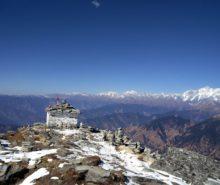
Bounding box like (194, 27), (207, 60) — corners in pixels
(125, 116), (192, 151)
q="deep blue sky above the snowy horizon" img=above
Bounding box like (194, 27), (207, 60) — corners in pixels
(0, 0), (220, 94)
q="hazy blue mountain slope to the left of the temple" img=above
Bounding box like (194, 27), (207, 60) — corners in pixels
(0, 95), (50, 125)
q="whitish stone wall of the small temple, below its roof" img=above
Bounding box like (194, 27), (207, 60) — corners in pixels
(46, 113), (77, 128)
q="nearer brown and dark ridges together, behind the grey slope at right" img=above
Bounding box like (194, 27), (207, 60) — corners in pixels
(124, 116), (220, 160)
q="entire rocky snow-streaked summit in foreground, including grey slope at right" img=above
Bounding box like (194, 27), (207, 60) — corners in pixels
(0, 124), (220, 185)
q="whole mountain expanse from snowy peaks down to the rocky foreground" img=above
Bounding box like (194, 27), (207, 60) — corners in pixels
(0, 87), (220, 159)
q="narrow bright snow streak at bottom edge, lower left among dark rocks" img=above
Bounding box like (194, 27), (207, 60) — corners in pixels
(20, 168), (49, 185)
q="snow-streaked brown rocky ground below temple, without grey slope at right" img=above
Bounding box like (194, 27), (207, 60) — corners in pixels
(0, 125), (192, 185)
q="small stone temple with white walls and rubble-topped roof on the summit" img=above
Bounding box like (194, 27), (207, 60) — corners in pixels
(46, 101), (80, 128)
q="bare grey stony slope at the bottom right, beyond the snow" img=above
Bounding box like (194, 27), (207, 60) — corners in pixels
(151, 147), (220, 185)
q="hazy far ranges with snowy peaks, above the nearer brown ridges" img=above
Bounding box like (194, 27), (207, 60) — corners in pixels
(0, 87), (220, 127)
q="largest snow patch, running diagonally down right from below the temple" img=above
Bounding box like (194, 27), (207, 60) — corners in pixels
(76, 134), (187, 185)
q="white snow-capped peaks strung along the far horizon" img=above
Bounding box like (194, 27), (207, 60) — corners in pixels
(2, 86), (220, 103)
